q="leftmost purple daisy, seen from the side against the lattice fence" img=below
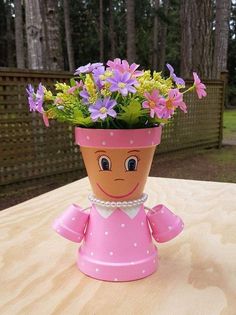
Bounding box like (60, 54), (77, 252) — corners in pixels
(26, 83), (44, 114)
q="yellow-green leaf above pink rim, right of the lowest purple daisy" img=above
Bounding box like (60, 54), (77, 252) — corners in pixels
(116, 100), (146, 127)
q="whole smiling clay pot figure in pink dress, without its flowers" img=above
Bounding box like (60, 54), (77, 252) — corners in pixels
(53, 127), (183, 281)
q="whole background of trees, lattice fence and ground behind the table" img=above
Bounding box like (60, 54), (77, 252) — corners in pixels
(0, 0), (236, 209)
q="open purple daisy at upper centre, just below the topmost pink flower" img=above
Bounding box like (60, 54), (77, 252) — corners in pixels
(107, 70), (138, 96)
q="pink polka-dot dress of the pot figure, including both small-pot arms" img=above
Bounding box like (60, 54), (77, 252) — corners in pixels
(53, 205), (183, 281)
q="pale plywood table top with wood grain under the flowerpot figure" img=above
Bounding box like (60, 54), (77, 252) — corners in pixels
(0, 177), (236, 315)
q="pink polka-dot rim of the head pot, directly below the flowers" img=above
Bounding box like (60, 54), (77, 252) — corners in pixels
(75, 126), (162, 149)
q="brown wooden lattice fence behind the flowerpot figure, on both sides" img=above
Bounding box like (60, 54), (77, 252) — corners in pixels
(0, 69), (224, 200)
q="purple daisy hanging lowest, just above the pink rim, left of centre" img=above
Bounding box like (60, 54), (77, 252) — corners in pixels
(89, 97), (117, 121)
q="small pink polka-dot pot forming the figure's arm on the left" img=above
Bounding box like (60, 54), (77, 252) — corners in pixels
(52, 204), (89, 243)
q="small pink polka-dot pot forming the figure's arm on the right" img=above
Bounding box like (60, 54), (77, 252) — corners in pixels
(147, 205), (184, 243)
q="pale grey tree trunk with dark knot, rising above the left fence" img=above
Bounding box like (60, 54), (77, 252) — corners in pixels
(25, 0), (44, 69)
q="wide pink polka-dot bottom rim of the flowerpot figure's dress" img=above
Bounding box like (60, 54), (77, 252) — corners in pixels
(77, 248), (158, 282)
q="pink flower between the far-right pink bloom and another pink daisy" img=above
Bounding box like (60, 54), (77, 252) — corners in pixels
(158, 89), (187, 119)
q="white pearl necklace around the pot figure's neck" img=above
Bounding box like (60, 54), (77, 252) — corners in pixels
(88, 194), (148, 208)
